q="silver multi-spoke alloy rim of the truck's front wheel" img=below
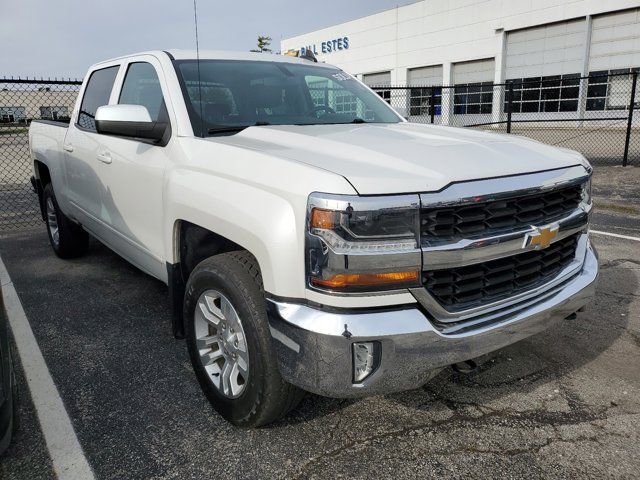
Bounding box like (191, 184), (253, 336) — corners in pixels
(194, 290), (249, 398)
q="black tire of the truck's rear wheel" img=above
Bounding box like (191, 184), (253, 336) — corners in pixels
(42, 183), (89, 258)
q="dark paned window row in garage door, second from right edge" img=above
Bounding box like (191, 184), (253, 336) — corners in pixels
(504, 73), (580, 113)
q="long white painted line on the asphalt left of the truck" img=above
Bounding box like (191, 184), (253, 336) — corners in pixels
(0, 258), (95, 480)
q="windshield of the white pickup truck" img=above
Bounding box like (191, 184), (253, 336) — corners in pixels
(175, 60), (401, 136)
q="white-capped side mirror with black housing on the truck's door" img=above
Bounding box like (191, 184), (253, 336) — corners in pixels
(95, 105), (167, 141)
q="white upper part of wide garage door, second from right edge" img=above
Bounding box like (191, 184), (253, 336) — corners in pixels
(506, 20), (586, 80)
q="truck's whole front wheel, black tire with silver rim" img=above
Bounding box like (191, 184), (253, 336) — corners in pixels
(184, 251), (303, 427)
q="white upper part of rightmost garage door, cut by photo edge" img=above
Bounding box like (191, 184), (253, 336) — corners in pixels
(589, 9), (640, 72)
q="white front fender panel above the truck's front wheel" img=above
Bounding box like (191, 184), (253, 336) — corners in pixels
(164, 170), (356, 298)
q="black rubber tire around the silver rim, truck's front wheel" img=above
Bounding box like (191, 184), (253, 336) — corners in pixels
(184, 251), (304, 427)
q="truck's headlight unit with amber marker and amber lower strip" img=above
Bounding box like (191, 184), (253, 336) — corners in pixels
(306, 194), (421, 293)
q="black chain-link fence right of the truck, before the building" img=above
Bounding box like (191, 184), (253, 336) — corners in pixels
(372, 69), (640, 165)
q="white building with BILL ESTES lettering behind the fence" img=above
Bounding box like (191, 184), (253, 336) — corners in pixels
(281, 0), (640, 123)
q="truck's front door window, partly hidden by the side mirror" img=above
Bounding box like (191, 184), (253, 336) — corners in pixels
(118, 62), (164, 122)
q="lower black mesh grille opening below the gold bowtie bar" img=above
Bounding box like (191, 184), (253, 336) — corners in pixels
(422, 233), (581, 312)
